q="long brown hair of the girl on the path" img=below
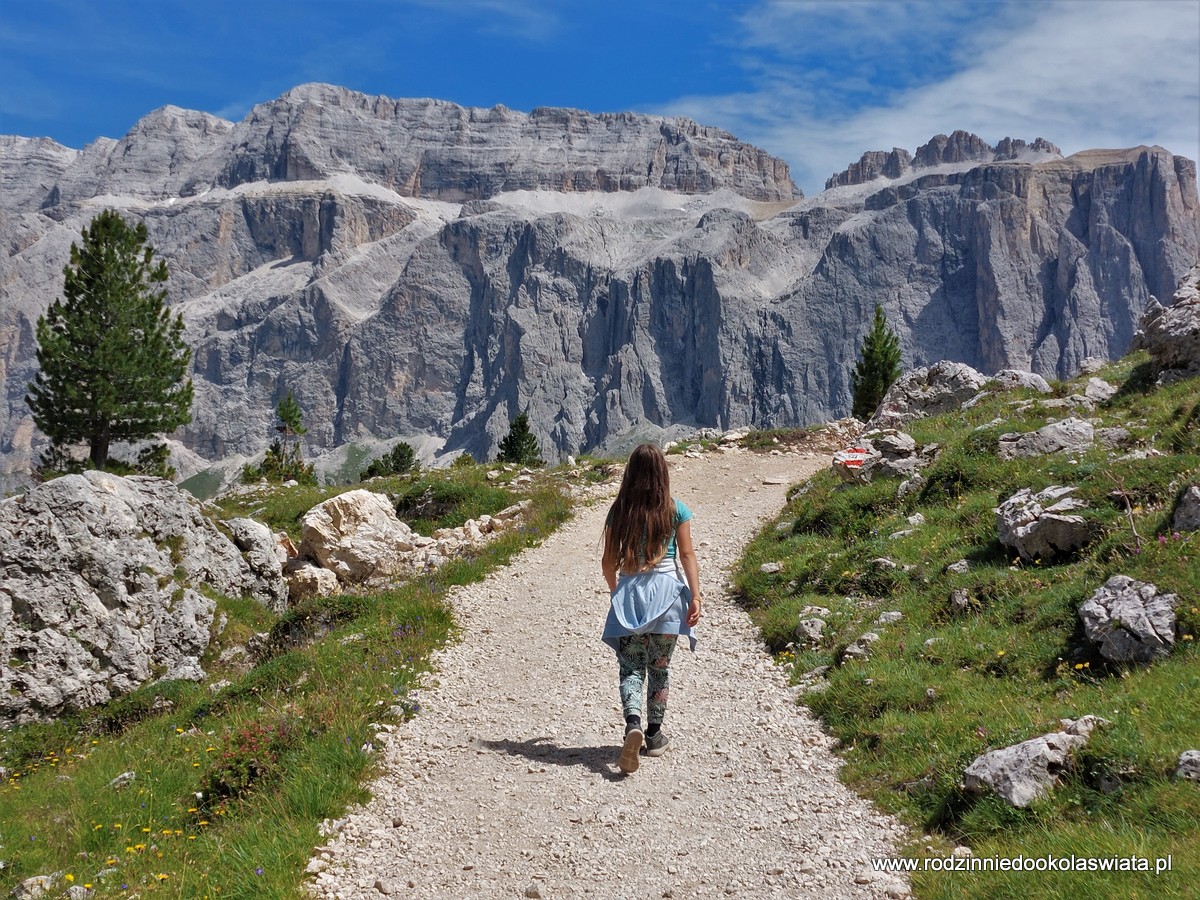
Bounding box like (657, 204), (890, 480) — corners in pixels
(604, 444), (674, 572)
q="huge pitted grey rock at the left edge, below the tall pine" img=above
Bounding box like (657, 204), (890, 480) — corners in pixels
(0, 472), (280, 724)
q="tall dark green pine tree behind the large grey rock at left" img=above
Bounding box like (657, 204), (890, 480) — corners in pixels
(25, 210), (192, 468)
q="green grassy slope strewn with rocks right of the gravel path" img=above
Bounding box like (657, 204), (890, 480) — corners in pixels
(736, 356), (1200, 899)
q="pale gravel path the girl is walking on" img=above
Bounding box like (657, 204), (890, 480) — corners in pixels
(308, 450), (907, 900)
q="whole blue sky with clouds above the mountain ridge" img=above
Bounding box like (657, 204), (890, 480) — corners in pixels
(0, 0), (1200, 193)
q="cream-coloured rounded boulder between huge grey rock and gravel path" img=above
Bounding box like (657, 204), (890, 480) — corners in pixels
(300, 488), (414, 584)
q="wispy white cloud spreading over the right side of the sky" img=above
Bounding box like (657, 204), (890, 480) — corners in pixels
(668, 0), (1200, 193)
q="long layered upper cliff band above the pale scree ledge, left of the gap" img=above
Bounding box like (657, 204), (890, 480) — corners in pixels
(36, 84), (799, 211)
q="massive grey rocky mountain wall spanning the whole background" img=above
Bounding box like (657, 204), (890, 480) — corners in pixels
(0, 85), (1200, 487)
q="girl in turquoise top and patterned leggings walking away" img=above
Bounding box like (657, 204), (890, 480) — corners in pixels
(601, 444), (701, 774)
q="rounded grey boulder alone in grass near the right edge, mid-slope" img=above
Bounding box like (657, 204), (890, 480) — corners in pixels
(1079, 575), (1178, 662)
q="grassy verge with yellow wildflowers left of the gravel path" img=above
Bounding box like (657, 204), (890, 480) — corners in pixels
(0, 486), (570, 898)
